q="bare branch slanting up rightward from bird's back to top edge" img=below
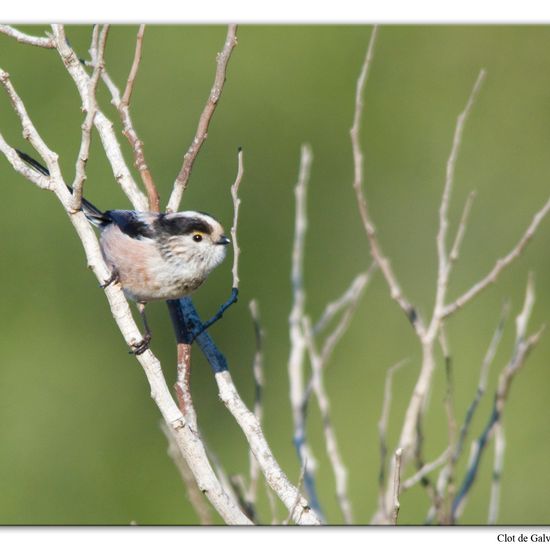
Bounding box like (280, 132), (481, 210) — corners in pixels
(166, 25), (237, 212)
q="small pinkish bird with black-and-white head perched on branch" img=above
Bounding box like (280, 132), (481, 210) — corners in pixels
(17, 151), (231, 355)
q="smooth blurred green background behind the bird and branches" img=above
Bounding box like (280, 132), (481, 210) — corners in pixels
(0, 25), (550, 524)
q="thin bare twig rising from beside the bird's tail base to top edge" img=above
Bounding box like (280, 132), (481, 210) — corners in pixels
(71, 25), (109, 211)
